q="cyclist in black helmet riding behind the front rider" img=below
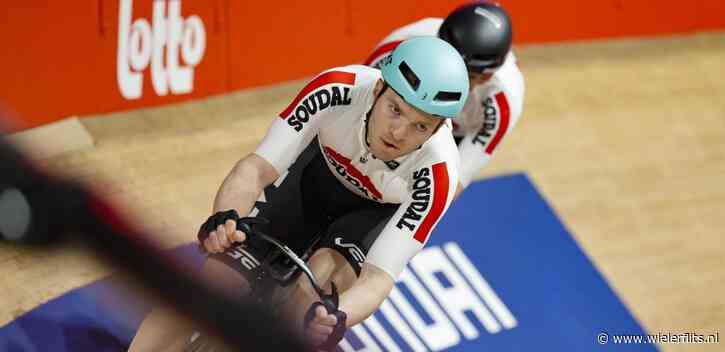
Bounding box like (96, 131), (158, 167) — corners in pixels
(365, 1), (524, 196)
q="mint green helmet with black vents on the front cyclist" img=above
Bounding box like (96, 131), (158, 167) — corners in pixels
(380, 37), (469, 118)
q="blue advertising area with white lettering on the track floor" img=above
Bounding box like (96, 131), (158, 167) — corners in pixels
(0, 174), (657, 352)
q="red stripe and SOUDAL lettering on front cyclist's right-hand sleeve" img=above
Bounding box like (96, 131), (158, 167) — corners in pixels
(396, 162), (449, 243)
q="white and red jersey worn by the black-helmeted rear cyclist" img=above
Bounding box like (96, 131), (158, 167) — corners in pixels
(365, 18), (524, 187)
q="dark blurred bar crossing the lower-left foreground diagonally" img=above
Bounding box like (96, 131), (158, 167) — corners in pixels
(0, 134), (306, 351)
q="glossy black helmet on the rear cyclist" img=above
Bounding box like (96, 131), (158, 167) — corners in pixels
(438, 2), (512, 72)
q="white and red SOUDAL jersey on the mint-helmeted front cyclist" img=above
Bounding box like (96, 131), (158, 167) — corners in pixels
(255, 65), (458, 279)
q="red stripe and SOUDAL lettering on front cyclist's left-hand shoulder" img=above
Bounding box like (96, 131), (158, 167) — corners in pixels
(279, 71), (355, 132)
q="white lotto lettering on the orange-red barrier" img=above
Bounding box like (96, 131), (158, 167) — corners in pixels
(116, 0), (206, 100)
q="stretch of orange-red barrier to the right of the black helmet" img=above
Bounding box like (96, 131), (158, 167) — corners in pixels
(503, 0), (725, 43)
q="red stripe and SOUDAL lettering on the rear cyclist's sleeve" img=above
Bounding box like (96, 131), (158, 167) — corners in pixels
(472, 92), (510, 154)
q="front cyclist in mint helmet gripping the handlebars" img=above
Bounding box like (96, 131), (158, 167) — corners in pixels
(131, 37), (469, 351)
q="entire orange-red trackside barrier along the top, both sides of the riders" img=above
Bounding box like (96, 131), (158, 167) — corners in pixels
(0, 0), (725, 129)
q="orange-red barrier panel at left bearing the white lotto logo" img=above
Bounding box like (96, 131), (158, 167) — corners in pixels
(0, 0), (228, 129)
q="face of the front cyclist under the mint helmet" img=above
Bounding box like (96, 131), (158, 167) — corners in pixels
(367, 81), (443, 161)
